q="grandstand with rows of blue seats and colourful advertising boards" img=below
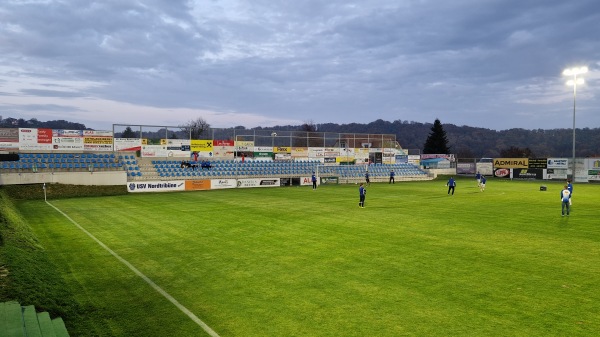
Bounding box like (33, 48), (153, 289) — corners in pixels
(0, 127), (431, 185)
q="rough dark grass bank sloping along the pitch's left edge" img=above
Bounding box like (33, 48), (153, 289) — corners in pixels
(0, 184), (126, 336)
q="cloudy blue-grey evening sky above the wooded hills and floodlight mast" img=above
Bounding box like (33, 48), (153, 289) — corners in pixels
(0, 0), (600, 130)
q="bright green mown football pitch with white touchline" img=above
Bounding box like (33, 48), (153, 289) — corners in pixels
(10, 179), (600, 337)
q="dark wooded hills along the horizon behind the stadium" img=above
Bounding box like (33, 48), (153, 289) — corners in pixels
(0, 118), (600, 158)
